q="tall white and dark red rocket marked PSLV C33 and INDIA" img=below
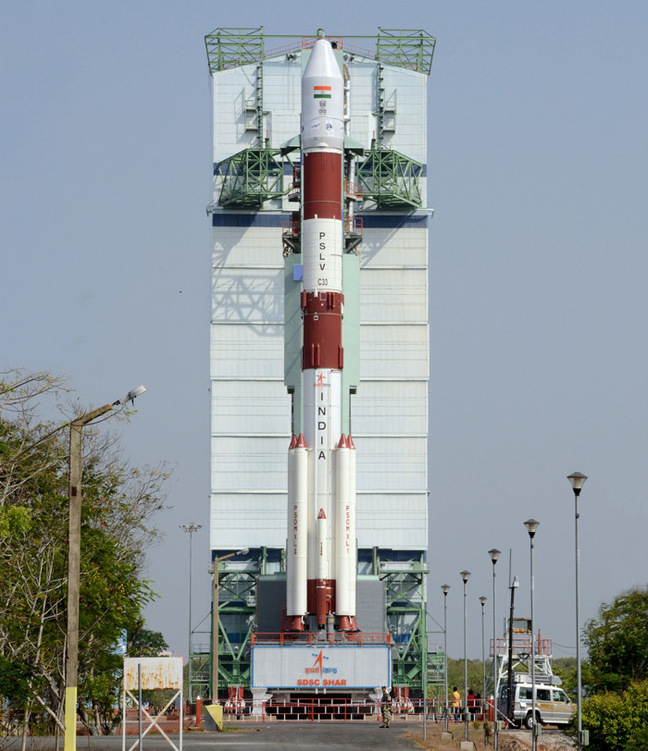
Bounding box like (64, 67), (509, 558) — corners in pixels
(286, 38), (358, 631)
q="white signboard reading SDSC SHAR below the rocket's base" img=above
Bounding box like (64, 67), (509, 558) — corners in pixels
(251, 645), (391, 690)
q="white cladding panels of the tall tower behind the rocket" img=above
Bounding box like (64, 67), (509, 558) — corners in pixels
(210, 56), (429, 550)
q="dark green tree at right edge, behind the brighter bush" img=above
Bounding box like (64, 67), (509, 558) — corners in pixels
(583, 587), (648, 692)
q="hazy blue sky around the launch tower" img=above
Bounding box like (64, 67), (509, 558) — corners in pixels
(0, 0), (648, 657)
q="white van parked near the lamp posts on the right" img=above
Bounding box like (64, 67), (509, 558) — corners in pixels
(498, 675), (576, 728)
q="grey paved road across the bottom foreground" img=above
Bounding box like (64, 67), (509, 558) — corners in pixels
(0, 722), (421, 751)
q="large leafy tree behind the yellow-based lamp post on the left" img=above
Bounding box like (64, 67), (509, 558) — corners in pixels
(0, 371), (168, 729)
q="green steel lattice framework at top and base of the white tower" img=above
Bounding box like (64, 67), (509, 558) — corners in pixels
(201, 26), (436, 697)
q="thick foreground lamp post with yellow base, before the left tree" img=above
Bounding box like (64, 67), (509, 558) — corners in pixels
(64, 386), (146, 751)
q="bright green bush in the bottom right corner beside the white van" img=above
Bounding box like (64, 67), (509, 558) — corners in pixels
(571, 681), (648, 751)
